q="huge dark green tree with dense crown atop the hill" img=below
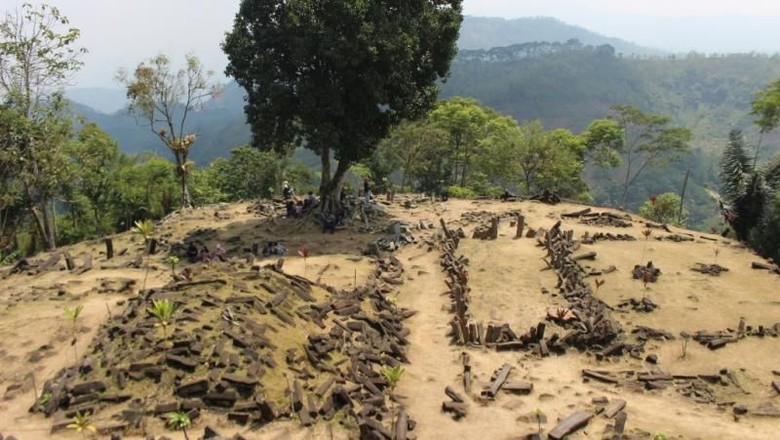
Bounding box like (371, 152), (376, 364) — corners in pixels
(223, 0), (462, 209)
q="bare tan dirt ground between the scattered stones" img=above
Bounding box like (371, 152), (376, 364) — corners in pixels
(0, 197), (780, 440)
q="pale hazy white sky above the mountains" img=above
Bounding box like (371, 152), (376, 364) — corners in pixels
(0, 0), (780, 87)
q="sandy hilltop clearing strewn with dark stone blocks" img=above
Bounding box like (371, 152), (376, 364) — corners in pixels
(0, 196), (780, 440)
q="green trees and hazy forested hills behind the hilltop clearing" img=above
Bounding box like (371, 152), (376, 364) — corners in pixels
(0, 6), (780, 260)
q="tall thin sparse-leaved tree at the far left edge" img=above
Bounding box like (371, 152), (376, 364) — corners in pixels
(0, 3), (86, 249)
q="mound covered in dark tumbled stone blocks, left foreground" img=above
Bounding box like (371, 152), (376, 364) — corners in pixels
(31, 258), (413, 438)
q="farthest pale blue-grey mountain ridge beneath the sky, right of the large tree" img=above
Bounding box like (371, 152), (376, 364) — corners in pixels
(458, 17), (666, 55)
